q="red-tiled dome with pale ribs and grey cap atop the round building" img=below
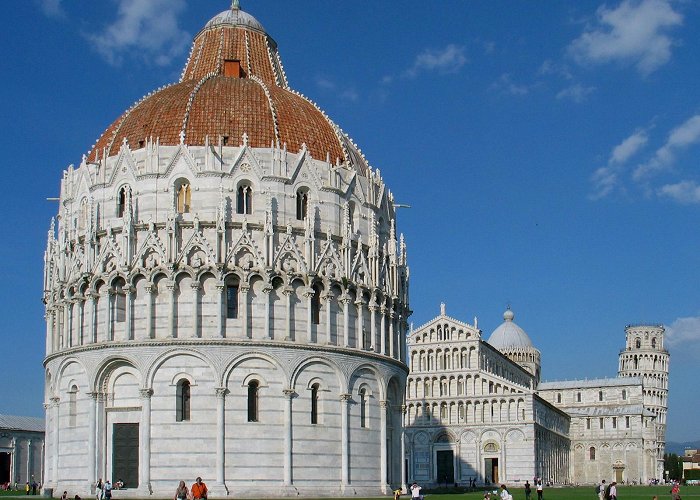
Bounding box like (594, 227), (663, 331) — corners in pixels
(88, 7), (348, 165)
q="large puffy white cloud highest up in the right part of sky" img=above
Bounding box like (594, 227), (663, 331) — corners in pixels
(569, 0), (683, 75)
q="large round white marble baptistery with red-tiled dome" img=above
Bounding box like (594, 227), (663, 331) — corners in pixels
(44, 2), (410, 498)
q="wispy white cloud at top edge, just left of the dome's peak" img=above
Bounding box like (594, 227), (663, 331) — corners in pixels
(88, 0), (191, 66)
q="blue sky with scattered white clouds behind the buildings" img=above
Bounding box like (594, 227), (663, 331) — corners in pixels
(0, 0), (700, 441)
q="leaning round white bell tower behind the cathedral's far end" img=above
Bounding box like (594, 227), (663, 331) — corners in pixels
(618, 325), (669, 477)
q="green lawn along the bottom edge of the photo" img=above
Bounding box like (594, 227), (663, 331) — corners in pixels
(0, 486), (700, 500)
